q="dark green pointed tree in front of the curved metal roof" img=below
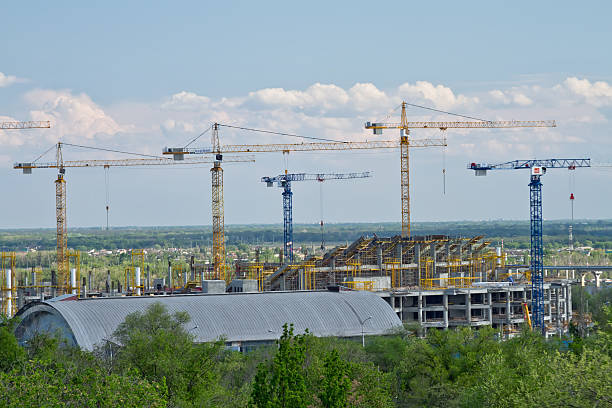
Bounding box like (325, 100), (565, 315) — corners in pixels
(249, 324), (312, 408)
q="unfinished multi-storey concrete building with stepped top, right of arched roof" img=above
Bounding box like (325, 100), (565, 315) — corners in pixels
(241, 235), (572, 336)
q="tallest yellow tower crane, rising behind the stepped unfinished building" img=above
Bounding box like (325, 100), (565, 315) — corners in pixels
(365, 102), (556, 238)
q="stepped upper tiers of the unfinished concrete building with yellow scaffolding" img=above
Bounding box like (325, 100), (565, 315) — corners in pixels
(263, 235), (505, 291)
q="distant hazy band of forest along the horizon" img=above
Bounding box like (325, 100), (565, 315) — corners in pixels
(0, 220), (612, 251)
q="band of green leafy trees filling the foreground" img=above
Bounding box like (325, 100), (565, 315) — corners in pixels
(0, 293), (612, 408)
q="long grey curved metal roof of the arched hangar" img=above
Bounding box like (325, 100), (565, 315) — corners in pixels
(17, 292), (401, 350)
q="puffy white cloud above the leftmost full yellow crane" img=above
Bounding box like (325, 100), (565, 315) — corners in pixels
(25, 89), (122, 142)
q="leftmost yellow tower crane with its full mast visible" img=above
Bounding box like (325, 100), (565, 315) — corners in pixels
(13, 142), (255, 294)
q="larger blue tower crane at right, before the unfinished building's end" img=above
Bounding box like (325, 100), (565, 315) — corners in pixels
(467, 159), (591, 334)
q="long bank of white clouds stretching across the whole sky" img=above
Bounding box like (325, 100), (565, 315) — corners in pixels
(5, 78), (610, 166)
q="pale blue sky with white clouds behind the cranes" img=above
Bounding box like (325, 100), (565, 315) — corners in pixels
(0, 1), (612, 229)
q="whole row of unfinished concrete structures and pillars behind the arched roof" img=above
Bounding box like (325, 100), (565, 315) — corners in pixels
(2, 235), (577, 342)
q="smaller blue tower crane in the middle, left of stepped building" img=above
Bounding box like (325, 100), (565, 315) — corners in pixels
(261, 171), (370, 264)
